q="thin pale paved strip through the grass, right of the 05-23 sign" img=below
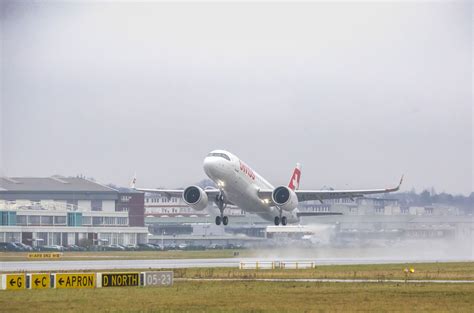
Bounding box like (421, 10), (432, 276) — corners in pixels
(175, 278), (474, 284)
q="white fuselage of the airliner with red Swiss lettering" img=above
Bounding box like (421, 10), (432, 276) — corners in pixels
(204, 150), (298, 223)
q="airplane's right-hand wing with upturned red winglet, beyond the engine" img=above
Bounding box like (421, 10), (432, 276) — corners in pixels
(259, 176), (403, 202)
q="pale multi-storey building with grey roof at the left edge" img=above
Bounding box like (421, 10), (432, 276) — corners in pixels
(0, 176), (148, 246)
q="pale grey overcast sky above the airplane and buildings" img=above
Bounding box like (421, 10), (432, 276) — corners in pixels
(0, 1), (473, 194)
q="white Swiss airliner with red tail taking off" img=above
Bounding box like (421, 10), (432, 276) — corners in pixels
(131, 150), (403, 226)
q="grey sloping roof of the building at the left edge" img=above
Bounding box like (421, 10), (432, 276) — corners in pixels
(0, 176), (117, 193)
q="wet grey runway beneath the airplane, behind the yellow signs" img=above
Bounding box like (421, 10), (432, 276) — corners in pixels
(0, 258), (473, 272)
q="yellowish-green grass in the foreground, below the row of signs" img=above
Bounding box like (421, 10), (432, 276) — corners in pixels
(0, 281), (474, 313)
